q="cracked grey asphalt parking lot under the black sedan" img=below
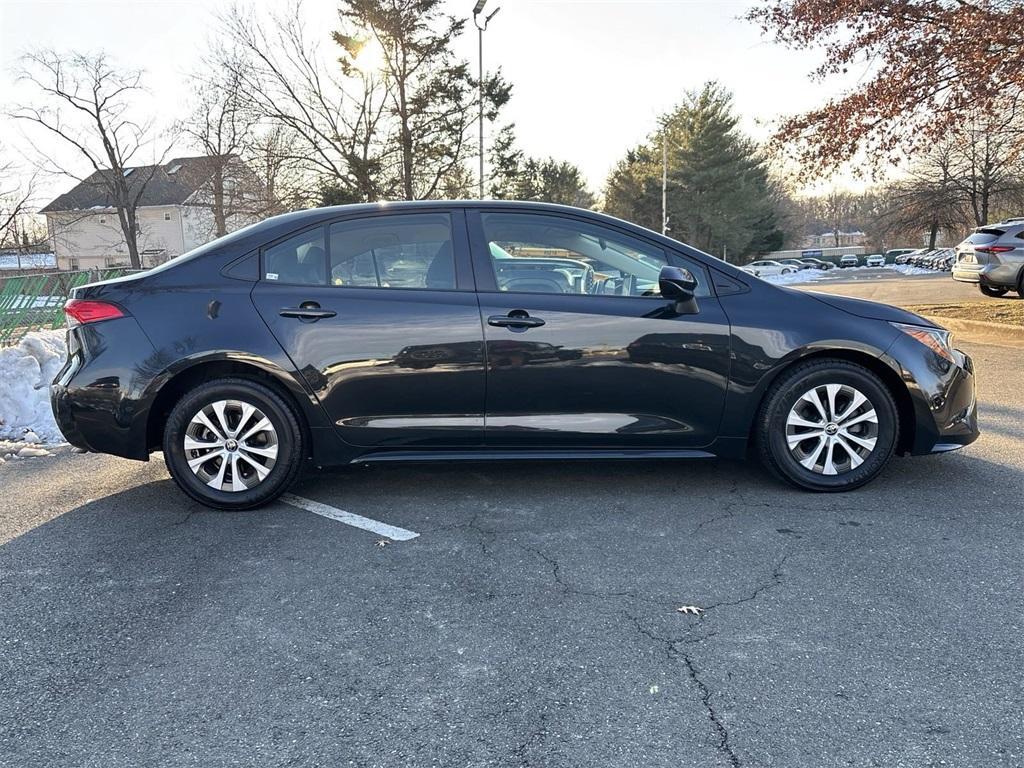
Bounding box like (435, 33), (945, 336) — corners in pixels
(0, 279), (1024, 768)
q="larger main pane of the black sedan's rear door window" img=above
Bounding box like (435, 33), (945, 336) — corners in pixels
(330, 213), (456, 290)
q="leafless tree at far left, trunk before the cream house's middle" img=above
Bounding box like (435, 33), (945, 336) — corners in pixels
(11, 50), (169, 268)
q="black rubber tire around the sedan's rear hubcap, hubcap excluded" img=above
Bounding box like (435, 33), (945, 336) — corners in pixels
(163, 379), (305, 510)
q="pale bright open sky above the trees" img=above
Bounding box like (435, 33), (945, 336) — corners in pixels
(0, 0), (841, 204)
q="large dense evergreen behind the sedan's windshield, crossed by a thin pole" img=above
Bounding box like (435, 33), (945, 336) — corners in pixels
(605, 83), (783, 257)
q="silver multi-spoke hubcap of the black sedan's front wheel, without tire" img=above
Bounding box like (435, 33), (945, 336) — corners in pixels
(785, 384), (879, 475)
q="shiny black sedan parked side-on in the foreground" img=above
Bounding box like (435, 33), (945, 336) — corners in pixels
(51, 202), (978, 509)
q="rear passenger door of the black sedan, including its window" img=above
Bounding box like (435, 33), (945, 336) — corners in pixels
(253, 210), (484, 449)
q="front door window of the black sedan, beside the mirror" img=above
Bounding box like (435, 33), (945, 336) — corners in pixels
(481, 213), (710, 296)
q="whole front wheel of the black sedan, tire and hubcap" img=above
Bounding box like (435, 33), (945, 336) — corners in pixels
(757, 359), (899, 492)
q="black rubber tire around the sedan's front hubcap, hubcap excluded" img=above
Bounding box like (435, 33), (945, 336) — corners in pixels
(755, 358), (899, 493)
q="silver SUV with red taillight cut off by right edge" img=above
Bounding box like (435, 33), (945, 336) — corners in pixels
(952, 217), (1024, 297)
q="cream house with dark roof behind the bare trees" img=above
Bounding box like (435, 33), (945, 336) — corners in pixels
(41, 156), (267, 269)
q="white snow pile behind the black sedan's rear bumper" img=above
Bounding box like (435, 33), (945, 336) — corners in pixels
(0, 331), (68, 455)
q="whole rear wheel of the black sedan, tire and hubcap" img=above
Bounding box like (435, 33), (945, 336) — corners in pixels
(164, 379), (303, 510)
